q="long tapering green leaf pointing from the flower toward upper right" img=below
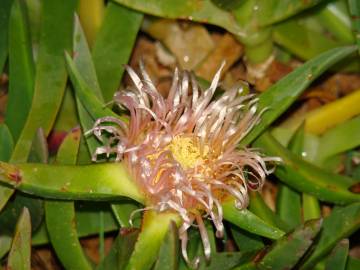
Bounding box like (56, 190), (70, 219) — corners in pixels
(240, 46), (356, 146)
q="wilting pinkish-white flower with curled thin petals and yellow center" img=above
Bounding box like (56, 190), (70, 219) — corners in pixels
(91, 63), (278, 266)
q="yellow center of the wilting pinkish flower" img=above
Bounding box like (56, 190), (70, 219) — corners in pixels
(166, 135), (209, 169)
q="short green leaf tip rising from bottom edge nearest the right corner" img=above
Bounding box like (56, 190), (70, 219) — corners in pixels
(326, 239), (349, 270)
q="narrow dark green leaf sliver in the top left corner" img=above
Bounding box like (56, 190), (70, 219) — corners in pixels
(0, 0), (13, 73)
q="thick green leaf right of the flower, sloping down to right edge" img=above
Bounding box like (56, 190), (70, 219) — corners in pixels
(255, 132), (360, 204)
